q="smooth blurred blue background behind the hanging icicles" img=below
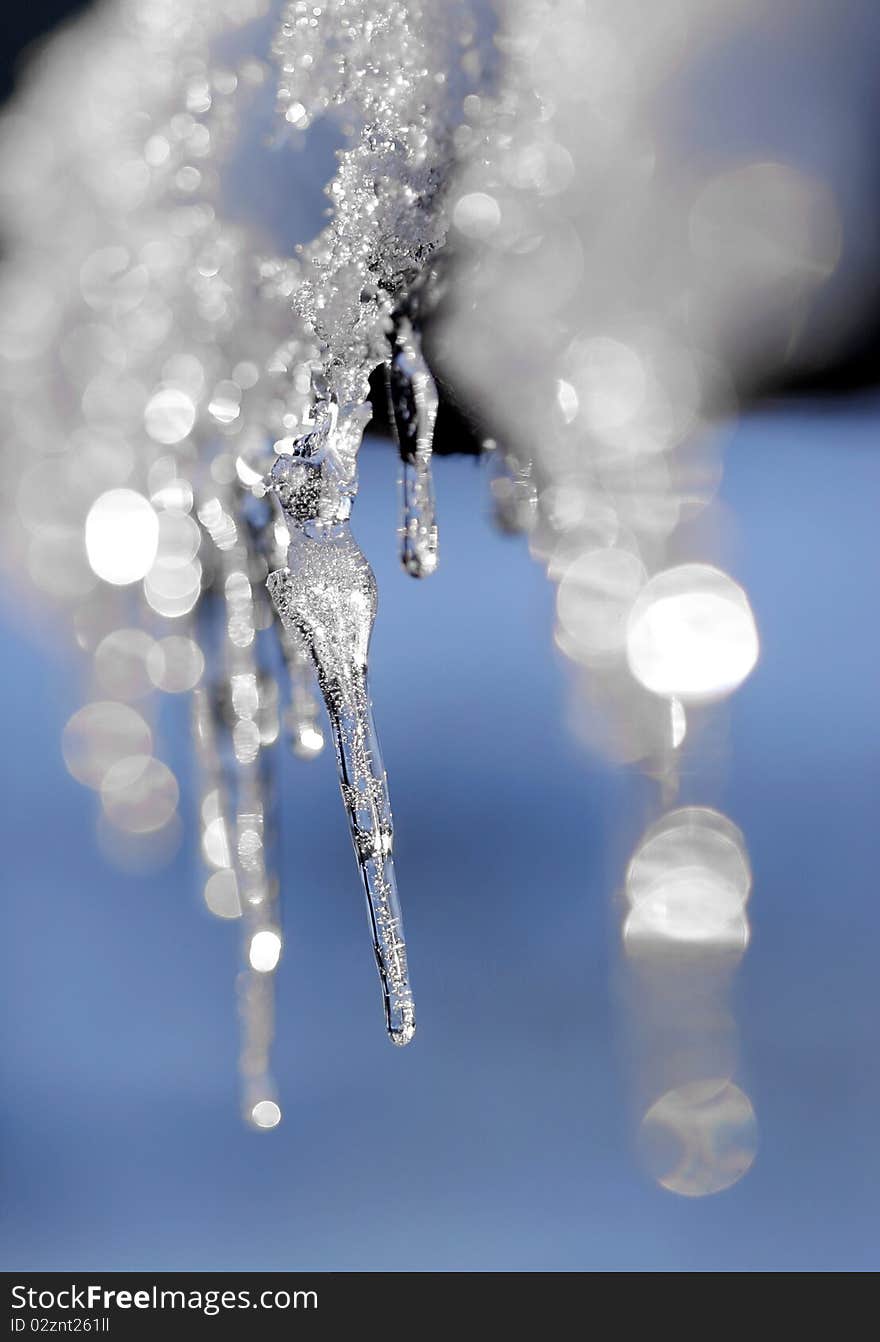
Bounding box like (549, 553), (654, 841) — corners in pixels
(0, 0), (880, 1271)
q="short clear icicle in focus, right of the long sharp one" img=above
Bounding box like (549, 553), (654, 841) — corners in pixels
(385, 317), (437, 578)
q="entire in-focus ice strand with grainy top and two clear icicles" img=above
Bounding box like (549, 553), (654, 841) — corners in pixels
(257, 0), (465, 1044)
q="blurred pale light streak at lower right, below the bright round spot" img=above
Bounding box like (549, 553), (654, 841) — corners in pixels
(622, 807), (758, 1197)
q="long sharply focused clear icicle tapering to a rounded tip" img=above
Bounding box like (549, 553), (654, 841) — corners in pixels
(267, 405), (416, 1044)
